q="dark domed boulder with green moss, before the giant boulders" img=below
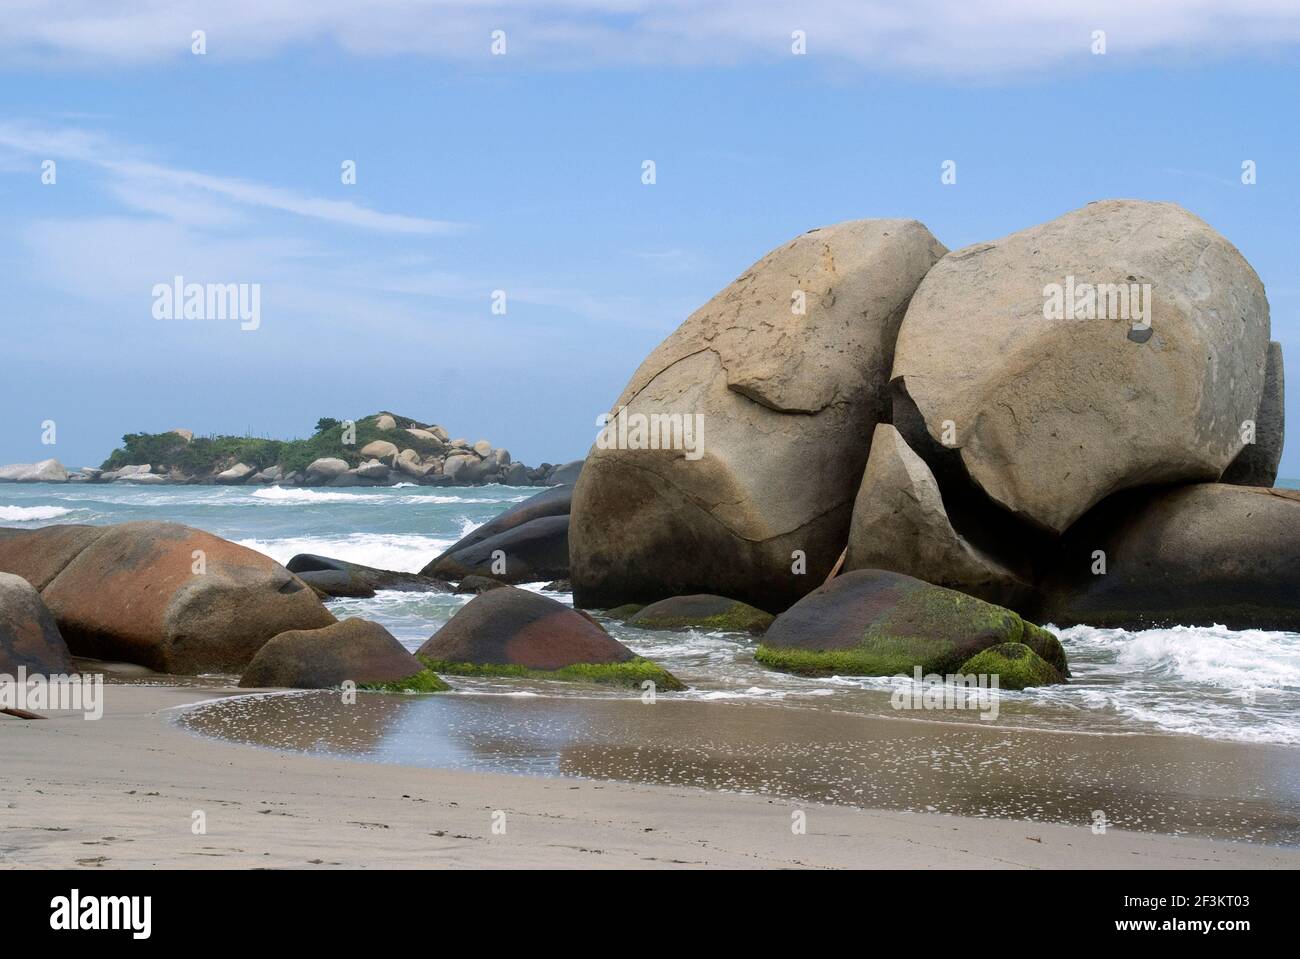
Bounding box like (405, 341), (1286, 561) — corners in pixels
(755, 569), (1069, 678)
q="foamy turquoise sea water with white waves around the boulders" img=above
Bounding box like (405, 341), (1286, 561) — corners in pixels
(0, 483), (1300, 745)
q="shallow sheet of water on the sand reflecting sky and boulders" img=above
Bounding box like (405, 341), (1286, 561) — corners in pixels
(178, 693), (1300, 845)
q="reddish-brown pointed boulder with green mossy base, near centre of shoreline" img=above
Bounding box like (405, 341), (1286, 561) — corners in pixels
(416, 586), (681, 689)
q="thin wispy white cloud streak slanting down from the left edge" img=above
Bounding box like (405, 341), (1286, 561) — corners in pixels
(0, 122), (464, 234)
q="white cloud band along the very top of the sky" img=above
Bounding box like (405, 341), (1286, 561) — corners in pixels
(0, 0), (1300, 75)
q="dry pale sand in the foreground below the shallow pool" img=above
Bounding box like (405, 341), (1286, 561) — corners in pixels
(0, 685), (1300, 869)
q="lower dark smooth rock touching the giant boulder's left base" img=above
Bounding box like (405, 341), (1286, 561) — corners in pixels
(421, 516), (569, 583)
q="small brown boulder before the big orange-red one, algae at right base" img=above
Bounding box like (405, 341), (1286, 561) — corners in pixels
(239, 619), (450, 693)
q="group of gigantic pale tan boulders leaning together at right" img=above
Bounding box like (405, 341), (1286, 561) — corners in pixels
(568, 200), (1300, 674)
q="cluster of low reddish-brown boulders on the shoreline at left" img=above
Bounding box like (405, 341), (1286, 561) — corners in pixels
(0, 514), (683, 693)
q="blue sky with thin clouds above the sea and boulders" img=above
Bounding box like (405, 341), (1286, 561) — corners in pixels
(0, 0), (1300, 477)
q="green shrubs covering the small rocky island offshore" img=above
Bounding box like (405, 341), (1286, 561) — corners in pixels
(101, 412), (446, 476)
